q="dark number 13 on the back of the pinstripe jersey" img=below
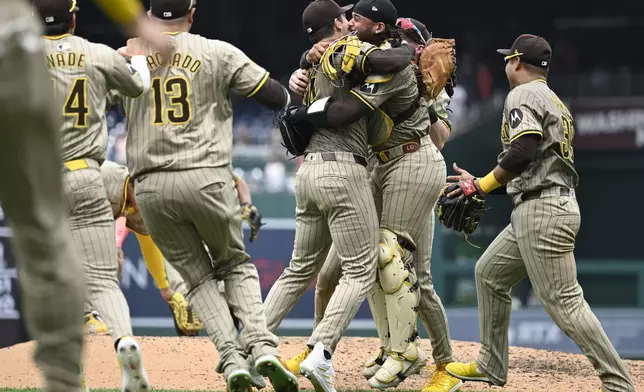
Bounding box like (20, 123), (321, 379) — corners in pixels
(151, 77), (192, 125)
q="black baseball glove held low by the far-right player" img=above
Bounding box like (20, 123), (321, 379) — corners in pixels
(437, 179), (485, 234)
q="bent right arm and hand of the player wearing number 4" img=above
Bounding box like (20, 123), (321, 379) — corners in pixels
(104, 38), (151, 98)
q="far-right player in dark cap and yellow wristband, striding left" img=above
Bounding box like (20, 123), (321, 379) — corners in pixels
(447, 34), (635, 392)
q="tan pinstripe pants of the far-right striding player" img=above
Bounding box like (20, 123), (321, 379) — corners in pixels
(475, 191), (635, 392)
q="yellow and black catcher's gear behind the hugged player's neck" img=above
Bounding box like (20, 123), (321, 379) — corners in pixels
(320, 33), (360, 87)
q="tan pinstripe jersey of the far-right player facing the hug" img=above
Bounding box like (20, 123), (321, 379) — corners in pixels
(499, 79), (579, 196)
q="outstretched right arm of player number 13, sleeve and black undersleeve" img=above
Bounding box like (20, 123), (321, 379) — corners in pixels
(220, 41), (291, 110)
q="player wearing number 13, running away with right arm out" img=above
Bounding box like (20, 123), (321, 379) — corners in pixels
(112, 0), (298, 392)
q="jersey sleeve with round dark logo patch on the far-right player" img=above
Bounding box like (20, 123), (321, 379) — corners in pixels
(503, 88), (545, 143)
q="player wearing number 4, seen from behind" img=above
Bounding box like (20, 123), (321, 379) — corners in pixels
(35, 0), (156, 391)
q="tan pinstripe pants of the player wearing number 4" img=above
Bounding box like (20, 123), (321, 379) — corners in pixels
(64, 160), (132, 340)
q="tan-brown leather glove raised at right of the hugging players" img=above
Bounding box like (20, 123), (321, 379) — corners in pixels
(418, 38), (456, 99)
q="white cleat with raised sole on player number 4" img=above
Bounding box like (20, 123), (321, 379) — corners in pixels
(116, 336), (150, 392)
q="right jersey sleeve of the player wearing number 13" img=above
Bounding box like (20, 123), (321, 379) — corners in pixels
(214, 41), (269, 97)
